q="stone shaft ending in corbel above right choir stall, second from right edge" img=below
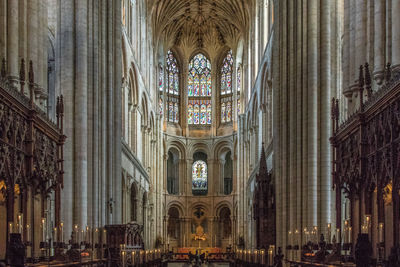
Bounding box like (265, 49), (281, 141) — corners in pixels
(373, 0), (386, 84)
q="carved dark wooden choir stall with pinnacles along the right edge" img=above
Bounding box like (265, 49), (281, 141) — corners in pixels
(331, 64), (400, 266)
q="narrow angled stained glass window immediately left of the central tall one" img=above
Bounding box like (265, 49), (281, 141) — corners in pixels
(164, 50), (179, 123)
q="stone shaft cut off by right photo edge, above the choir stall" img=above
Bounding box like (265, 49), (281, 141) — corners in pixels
(391, 0), (400, 72)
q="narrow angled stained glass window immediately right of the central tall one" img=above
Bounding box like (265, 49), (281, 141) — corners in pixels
(220, 50), (233, 123)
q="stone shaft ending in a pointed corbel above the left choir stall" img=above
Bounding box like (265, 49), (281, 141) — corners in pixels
(7, 0), (19, 82)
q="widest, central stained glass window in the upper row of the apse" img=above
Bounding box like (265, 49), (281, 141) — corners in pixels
(187, 53), (212, 125)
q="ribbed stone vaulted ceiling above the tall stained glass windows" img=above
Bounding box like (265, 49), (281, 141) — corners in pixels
(151, 0), (252, 54)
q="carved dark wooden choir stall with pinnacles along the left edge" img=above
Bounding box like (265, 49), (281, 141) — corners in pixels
(0, 59), (66, 266)
